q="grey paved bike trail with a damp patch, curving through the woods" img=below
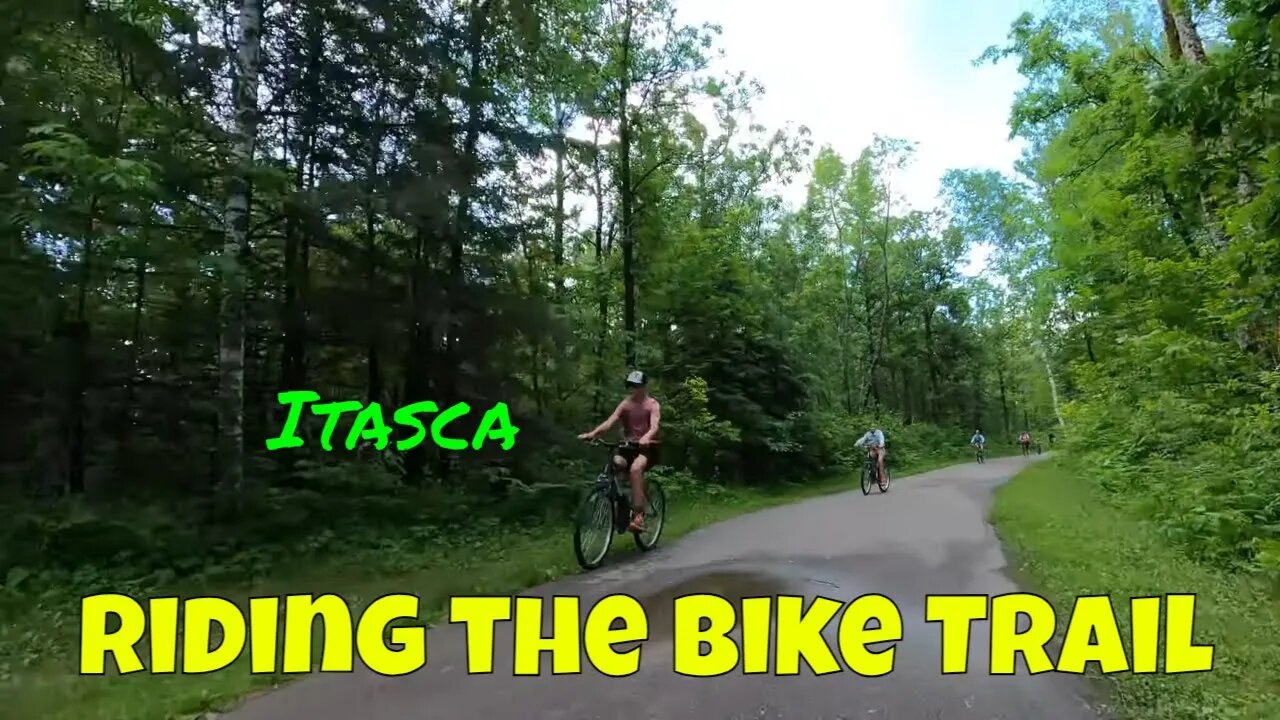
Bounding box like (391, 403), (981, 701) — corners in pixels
(224, 456), (1103, 720)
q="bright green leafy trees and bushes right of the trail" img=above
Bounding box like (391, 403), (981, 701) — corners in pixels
(952, 1), (1280, 571)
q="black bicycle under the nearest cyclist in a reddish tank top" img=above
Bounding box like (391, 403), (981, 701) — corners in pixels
(573, 441), (667, 570)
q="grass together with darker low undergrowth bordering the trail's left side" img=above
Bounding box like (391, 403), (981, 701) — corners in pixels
(0, 445), (998, 720)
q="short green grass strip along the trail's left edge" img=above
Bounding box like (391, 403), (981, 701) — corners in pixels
(0, 448), (1016, 720)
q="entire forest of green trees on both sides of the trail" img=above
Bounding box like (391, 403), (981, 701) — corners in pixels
(0, 0), (1280, 627)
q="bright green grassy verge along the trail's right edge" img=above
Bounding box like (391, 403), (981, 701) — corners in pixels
(992, 459), (1280, 720)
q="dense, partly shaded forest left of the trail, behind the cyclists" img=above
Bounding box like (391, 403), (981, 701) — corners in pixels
(0, 0), (1057, 584)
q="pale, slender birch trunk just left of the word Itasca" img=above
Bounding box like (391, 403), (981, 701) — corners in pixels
(218, 0), (262, 495)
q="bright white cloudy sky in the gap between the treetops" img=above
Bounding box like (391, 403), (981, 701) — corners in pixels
(673, 0), (1042, 273)
